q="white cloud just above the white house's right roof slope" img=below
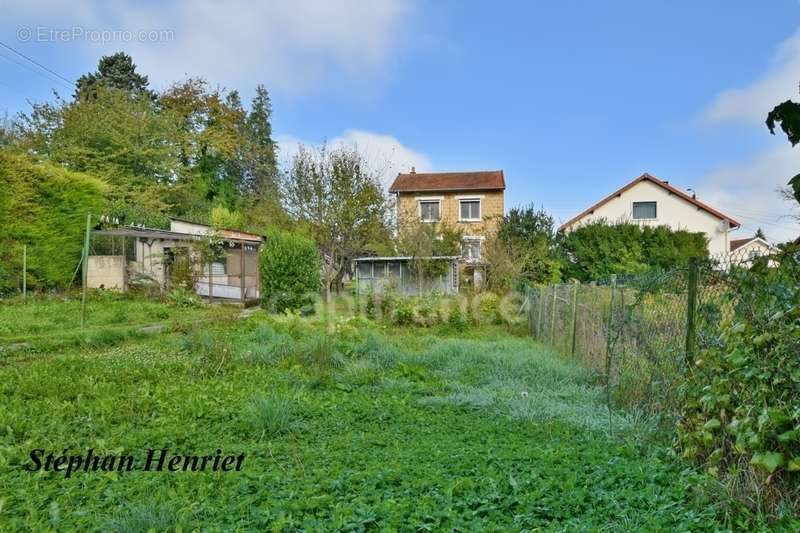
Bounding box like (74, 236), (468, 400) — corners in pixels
(696, 143), (800, 242)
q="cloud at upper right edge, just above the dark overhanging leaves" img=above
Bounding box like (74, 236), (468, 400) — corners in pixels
(700, 31), (800, 125)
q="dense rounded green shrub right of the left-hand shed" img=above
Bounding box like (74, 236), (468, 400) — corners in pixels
(260, 230), (321, 313)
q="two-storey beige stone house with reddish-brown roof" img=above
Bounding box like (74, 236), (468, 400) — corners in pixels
(389, 167), (506, 284)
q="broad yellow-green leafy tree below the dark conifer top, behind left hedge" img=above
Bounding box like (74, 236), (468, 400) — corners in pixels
(16, 86), (178, 226)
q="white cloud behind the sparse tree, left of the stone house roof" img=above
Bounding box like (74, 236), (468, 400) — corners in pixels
(276, 129), (433, 189)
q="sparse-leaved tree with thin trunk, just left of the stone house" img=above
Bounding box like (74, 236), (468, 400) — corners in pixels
(284, 146), (387, 302)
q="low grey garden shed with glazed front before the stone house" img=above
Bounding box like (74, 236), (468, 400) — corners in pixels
(355, 256), (460, 294)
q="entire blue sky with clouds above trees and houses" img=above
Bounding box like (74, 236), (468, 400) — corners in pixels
(0, 0), (800, 240)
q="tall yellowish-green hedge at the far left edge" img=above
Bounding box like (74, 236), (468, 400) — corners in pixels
(0, 151), (107, 294)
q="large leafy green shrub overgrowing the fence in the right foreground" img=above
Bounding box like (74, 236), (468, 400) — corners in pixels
(678, 255), (800, 511)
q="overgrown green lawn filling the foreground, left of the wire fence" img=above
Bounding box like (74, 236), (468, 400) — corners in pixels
(0, 310), (736, 531)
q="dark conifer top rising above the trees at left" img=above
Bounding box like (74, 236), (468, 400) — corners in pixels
(74, 52), (155, 100)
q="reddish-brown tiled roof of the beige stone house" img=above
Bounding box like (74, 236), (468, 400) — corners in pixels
(389, 168), (506, 192)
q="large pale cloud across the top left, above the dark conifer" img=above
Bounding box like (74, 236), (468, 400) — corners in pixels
(4, 0), (412, 93)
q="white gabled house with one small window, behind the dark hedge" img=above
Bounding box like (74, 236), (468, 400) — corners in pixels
(559, 173), (741, 257)
